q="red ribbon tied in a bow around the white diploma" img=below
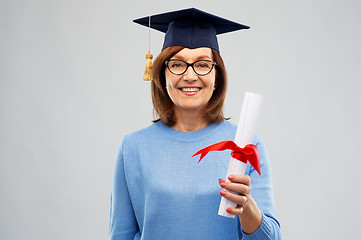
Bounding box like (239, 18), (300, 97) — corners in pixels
(192, 141), (261, 175)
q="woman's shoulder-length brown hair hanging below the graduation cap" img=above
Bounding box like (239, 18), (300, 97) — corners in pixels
(151, 46), (227, 126)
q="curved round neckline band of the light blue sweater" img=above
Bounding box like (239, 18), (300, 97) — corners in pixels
(155, 121), (225, 142)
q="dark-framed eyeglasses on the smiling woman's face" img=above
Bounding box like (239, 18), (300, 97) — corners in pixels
(165, 59), (216, 76)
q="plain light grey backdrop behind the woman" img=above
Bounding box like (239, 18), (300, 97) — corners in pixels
(0, 0), (361, 240)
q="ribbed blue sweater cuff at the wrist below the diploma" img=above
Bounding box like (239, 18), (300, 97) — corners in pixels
(243, 213), (281, 240)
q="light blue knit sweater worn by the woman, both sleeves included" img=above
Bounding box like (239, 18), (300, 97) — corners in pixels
(109, 121), (281, 240)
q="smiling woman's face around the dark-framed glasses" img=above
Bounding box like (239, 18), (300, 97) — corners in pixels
(165, 47), (216, 114)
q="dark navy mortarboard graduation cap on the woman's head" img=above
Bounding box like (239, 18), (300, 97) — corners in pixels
(133, 8), (249, 52)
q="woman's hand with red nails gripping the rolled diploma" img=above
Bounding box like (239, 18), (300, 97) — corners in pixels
(219, 175), (262, 234)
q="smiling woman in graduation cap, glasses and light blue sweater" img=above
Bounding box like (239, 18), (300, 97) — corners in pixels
(109, 8), (281, 240)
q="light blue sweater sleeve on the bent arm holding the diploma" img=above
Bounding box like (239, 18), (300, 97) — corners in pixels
(242, 135), (281, 240)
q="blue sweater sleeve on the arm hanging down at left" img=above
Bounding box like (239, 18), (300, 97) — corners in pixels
(109, 141), (138, 240)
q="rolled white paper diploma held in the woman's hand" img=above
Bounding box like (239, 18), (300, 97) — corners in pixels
(218, 92), (262, 218)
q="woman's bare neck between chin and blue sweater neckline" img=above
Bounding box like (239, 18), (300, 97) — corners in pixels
(172, 109), (209, 132)
